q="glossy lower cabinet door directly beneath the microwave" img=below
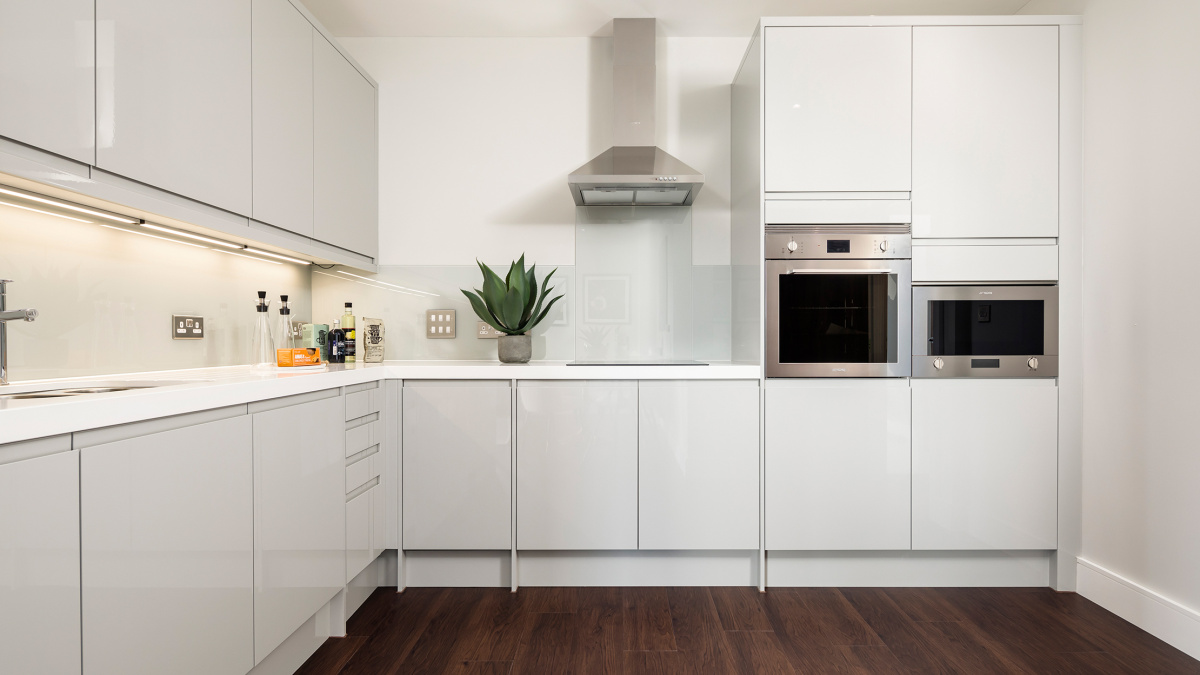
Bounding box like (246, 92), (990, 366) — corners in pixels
(912, 378), (1058, 550)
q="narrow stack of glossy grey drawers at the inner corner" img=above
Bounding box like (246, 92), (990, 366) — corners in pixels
(346, 382), (385, 584)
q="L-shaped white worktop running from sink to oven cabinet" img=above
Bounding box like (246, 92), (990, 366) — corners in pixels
(0, 360), (760, 444)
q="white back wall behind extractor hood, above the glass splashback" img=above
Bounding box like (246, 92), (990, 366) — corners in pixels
(342, 37), (748, 265)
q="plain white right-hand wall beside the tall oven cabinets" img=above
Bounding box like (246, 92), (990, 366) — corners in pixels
(1025, 0), (1200, 656)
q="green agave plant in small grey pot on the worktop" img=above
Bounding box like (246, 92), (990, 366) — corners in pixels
(462, 255), (563, 363)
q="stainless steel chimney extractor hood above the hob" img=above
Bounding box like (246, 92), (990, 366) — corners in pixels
(566, 19), (704, 207)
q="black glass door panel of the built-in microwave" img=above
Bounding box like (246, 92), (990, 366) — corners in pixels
(929, 300), (1045, 357)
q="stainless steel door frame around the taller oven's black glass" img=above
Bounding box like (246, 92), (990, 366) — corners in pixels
(766, 258), (912, 377)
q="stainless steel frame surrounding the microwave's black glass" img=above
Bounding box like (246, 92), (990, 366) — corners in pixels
(912, 285), (1058, 377)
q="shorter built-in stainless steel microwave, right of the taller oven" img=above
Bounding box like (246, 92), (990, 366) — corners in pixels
(912, 286), (1058, 377)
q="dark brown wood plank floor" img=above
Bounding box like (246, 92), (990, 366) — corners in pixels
(292, 587), (1200, 675)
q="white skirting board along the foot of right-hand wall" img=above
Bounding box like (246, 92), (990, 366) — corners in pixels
(1075, 557), (1200, 658)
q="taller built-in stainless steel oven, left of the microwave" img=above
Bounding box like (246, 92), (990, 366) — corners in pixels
(766, 225), (912, 377)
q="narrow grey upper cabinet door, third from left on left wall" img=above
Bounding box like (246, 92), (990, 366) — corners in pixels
(250, 0), (316, 237)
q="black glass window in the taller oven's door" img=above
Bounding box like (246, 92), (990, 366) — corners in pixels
(779, 270), (899, 364)
